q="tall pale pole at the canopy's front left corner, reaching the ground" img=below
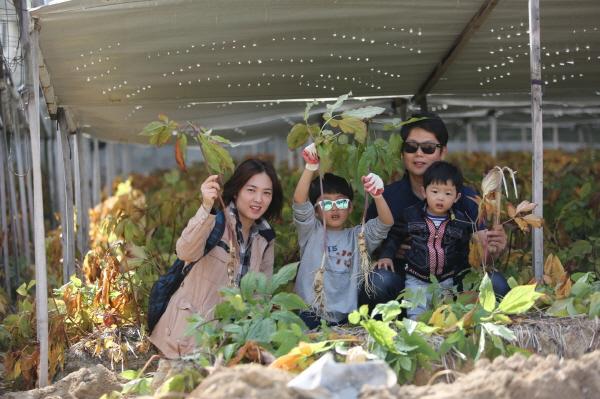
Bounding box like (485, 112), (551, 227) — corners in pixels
(23, 20), (48, 387)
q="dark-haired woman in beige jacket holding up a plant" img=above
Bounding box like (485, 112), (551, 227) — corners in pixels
(150, 159), (283, 358)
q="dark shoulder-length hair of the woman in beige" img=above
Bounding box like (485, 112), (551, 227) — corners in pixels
(223, 159), (283, 220)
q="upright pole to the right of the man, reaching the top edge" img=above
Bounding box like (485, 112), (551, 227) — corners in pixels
(529, 0), (544, 282)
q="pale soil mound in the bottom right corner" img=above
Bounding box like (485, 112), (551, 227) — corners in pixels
(360, 351), (600, 399)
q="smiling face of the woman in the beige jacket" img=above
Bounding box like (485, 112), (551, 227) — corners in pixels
(235, 172), (273, 223)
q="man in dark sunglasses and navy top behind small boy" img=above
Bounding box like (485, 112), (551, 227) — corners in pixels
(359, 113), (510, 306)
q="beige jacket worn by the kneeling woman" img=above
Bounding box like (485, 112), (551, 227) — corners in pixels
(150, 206), (275, 359)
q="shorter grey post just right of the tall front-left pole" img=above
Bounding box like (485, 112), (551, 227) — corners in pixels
(57, 108), (75, 284)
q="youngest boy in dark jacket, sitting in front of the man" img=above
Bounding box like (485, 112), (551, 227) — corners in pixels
(380, 161), (474, 319)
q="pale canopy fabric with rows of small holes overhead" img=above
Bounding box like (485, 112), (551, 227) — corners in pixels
(32, 0), (600, 142)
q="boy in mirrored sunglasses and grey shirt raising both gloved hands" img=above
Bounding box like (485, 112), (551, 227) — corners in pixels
(292, 144), (394, 329)
